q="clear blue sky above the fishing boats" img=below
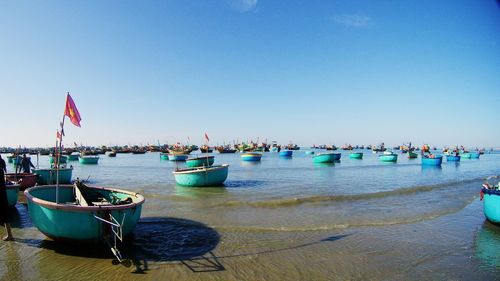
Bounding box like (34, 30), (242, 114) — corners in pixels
(0, 0), (500, 147)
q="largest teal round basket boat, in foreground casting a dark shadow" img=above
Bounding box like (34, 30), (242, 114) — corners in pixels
(24, 185), (144, 243)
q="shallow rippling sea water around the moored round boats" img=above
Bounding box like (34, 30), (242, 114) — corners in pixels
(0, 150), (500, 280)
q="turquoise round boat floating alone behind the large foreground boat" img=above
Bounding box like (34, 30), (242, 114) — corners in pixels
(173, 164), (229, 187)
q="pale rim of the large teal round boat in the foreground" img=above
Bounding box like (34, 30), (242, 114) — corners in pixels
(24, 184), (146, 212)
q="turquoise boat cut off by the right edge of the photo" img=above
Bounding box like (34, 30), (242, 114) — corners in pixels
(480, 176), (500, 224)
